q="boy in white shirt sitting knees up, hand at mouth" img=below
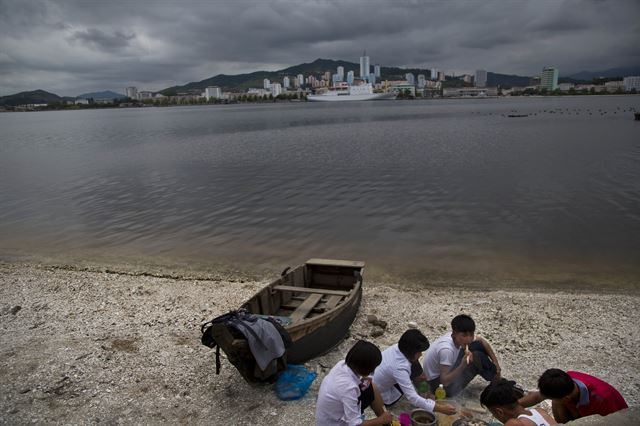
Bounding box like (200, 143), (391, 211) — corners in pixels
(423, 314), (500, 396)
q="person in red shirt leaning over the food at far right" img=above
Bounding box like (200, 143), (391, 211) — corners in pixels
(520, 368), (628, 423)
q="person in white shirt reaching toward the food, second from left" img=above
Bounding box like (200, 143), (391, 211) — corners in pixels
(373, 329), (456, 414)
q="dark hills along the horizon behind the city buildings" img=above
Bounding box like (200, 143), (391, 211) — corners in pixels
(0, 59), (640, 106)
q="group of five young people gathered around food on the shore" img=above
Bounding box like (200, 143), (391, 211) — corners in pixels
(316, 315), (627, 426)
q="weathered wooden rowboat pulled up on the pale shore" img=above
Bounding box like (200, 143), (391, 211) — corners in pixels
(208, 259), (364, 382)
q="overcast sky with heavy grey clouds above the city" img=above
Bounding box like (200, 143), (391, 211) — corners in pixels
(0, 0), (640, 96)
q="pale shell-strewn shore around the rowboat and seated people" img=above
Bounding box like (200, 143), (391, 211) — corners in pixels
(0, 264), (640, 425)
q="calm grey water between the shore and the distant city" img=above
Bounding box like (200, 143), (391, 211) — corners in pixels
(0, 96), (640, 286)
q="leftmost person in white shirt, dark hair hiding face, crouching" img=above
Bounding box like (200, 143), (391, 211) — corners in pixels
(316, 340), (393, 426)
